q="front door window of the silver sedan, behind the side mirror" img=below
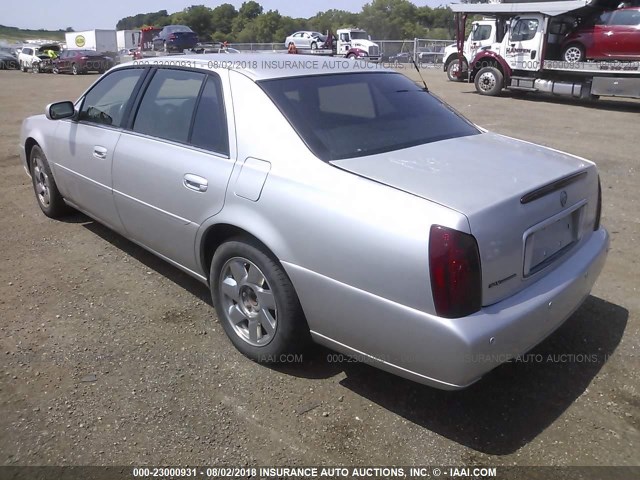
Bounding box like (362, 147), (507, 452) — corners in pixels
(78, 68), (144, 127)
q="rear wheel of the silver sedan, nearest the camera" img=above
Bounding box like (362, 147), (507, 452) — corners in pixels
(209, 238), (309, 363)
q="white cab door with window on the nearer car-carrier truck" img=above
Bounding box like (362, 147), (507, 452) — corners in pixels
(504, 15), (543, 70)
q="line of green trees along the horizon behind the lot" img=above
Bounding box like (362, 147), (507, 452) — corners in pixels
(116, 0), (455, 43)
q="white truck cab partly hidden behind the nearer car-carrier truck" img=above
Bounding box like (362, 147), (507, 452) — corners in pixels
(443, 18), (497, 82)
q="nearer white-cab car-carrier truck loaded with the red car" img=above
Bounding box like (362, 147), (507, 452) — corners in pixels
(451, 0), (640, 100)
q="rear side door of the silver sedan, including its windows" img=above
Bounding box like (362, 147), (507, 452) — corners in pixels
(113, 68), (235, 271)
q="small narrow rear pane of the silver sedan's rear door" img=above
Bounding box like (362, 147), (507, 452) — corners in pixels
(190, 75), (229, 155)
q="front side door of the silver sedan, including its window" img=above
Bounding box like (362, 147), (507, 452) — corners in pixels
(53, 68), (146, 231)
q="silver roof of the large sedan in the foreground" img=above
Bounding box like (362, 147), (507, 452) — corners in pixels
(116, 53), (395, 81)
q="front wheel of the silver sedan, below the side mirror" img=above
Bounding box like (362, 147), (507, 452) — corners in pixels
(29, 145), (71, 218)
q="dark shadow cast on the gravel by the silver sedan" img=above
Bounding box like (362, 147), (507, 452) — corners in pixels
(79, 214), (629, 455)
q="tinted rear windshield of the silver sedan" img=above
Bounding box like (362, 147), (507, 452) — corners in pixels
(259, 72), (480, 161)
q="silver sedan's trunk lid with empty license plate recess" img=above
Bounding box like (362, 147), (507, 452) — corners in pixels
(331, 133), (598, 305)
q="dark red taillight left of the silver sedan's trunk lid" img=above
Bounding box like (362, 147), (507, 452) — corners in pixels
(429, 225), (482, 318)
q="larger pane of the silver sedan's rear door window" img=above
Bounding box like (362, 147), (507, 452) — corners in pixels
(133, 69), (206, 143)
